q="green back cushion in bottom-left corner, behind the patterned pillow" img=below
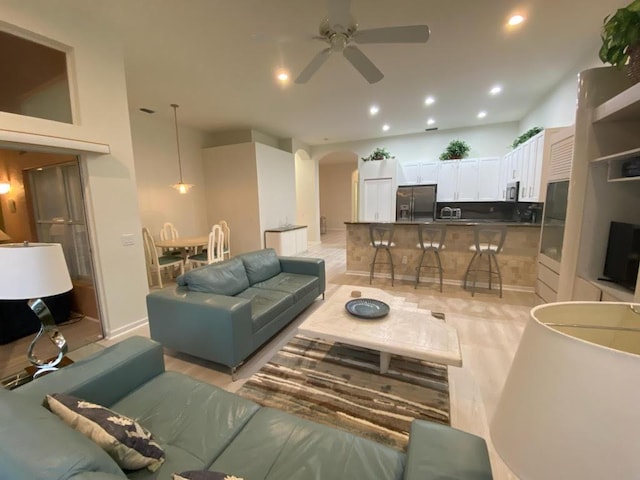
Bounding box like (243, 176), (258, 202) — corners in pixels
(0, 388), (126, 480)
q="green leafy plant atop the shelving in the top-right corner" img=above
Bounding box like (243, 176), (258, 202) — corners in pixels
(599, 0), (640, 83)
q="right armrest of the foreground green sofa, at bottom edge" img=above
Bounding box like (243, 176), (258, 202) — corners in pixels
(404, 420), (493, 480)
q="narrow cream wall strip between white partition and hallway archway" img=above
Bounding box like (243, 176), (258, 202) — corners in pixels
(295, 150), (320, 243)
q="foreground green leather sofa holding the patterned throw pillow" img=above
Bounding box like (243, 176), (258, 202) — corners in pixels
(0, 337), (492, 480)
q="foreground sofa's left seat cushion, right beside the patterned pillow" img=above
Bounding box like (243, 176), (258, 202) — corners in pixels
(111, 372), (259, 479)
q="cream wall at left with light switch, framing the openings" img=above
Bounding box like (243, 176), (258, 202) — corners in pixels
(0, 0), (149, 337)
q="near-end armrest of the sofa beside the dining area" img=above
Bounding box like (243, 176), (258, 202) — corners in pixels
(147, 287), (253, 367)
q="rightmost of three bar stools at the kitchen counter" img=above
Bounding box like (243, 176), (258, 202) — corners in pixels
(464, 225), (507, 298)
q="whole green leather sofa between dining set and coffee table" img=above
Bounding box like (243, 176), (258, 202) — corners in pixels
(147, 248), (326, 372)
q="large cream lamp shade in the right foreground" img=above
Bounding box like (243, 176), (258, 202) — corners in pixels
(490, 302), (640, 480)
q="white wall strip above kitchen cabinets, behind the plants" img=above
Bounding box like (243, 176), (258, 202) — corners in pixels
(311, 122), (518, 163)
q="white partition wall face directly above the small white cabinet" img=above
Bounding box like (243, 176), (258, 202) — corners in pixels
(254, 143), (297, 240)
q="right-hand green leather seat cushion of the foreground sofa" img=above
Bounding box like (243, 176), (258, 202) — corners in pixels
(209, 408), (404, 480)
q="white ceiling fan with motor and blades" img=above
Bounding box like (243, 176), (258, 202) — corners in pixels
(295, 0), (429, 83)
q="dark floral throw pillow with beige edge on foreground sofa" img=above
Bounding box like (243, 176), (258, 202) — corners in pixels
(47, 393), (164, 472)
